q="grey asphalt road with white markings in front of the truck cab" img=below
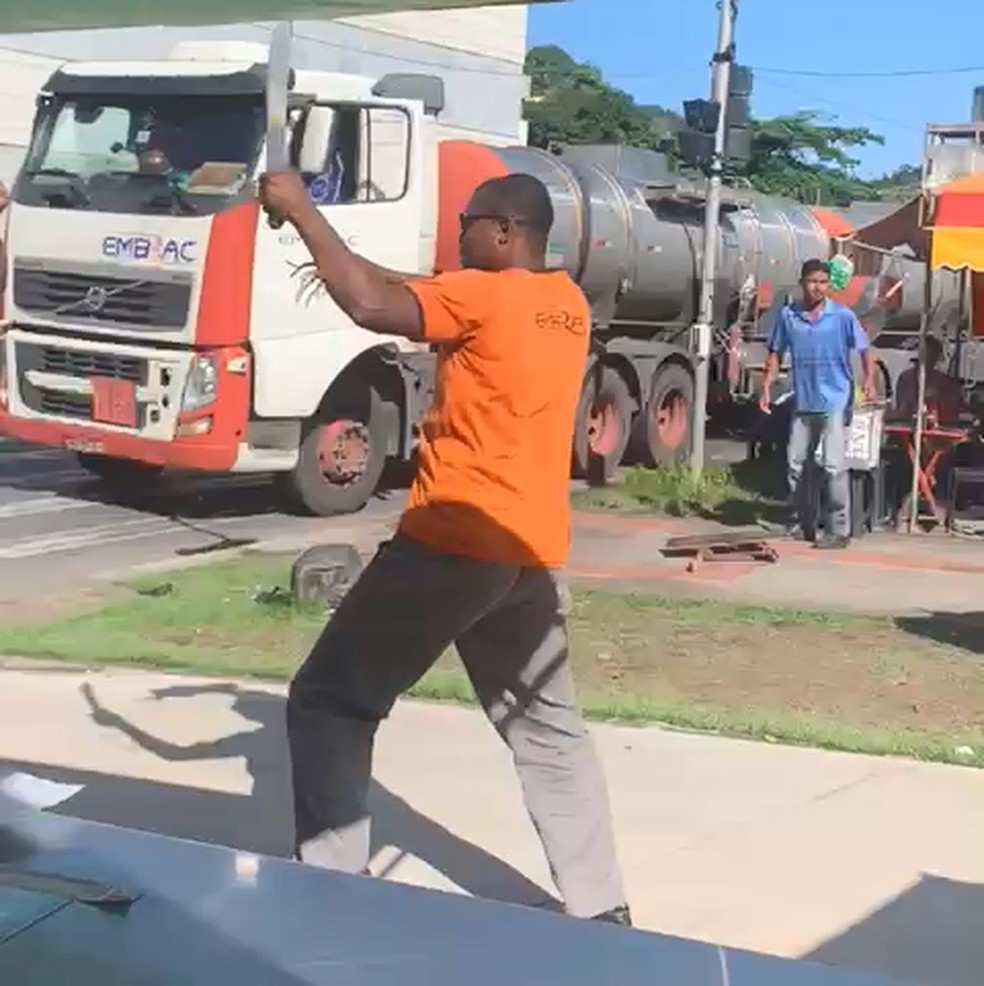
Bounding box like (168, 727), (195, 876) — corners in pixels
(0, 438), (403, 607)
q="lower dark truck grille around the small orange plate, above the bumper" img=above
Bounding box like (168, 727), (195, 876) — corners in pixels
(15, 343), (147, 426)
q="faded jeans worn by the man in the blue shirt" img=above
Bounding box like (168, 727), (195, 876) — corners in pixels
(786, 411), (851, 537)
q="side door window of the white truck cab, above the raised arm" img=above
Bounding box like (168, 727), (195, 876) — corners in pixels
(298, 105), (410, 206)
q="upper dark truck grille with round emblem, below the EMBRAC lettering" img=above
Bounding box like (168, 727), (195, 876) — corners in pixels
(14, 263), (191, 329)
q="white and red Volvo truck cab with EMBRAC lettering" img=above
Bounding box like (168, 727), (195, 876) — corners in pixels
(0, 43), (443, 514)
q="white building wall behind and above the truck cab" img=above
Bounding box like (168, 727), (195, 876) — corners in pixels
(0, 0), (528, 184)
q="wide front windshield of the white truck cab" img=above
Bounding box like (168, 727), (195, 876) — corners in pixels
(14, 95), (264, 215)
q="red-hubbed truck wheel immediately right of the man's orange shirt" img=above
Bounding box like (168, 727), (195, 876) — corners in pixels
(574, 366), (633, 479)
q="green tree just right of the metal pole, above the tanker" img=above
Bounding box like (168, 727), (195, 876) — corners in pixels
(733, 110), (884, 205)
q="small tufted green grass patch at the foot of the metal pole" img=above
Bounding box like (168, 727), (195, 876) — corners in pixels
(574, 460), (784, 525)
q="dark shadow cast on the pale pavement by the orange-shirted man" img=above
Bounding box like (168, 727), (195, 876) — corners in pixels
(2, 683), (558, 907)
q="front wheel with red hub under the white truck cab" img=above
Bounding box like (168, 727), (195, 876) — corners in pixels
(284, 387), (388, 517)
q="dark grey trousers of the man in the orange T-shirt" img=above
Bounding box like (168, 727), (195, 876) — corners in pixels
(287, 536), (625, 917)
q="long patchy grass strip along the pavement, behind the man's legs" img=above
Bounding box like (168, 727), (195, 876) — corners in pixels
(0, 554), (984, 766)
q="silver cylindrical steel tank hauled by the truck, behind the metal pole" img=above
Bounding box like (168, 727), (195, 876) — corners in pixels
(488, 145), (956, 340)
